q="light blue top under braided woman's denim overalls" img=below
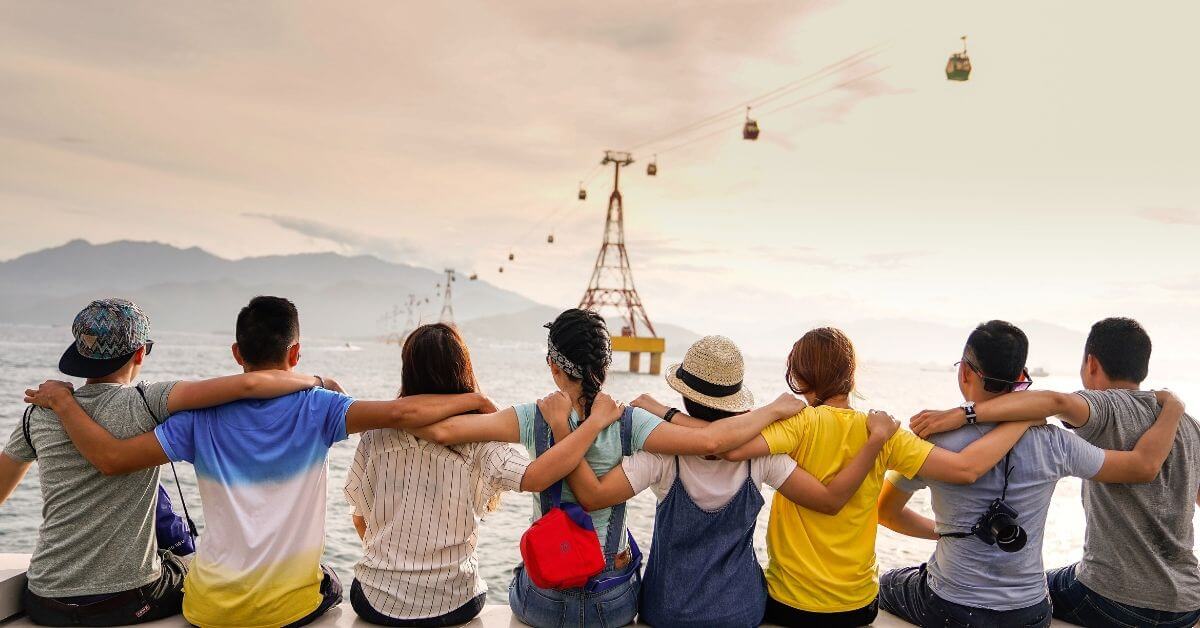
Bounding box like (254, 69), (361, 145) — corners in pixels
(512, 403), (662, 550)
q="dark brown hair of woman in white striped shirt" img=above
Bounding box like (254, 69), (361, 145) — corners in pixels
(400, 323), (479, 396)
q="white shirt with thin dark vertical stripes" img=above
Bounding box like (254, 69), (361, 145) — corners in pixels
(346, 430), (529, 620)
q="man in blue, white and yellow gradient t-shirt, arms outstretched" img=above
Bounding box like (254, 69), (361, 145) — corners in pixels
(29, 297), (494, 628)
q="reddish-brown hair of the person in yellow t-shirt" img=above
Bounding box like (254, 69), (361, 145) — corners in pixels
(787, 327), (857, 406)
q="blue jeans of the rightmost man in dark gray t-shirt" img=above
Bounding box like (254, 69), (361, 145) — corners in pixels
(1046, 563), (1200, 628)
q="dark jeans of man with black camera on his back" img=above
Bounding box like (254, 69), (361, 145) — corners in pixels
(880, 564), (1051, 628)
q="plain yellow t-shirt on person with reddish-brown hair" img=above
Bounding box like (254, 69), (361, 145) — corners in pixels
(762, 406), (934, 612)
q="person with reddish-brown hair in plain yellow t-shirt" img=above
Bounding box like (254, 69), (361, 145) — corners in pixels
(726, 328), (1046, 628)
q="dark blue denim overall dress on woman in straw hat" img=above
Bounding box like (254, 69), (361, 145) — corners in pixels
(640, 456), (767, 628)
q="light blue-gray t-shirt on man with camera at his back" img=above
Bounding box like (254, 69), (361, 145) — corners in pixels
(888, 424), (1104, 611)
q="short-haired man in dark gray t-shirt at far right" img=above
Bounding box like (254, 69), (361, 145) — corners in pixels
(913, 318), (1200, 628)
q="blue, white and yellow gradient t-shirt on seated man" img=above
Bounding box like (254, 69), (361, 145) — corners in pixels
(155, 389), (353, 627)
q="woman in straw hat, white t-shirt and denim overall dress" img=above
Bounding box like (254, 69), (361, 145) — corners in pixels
(556, 336), (900, 628)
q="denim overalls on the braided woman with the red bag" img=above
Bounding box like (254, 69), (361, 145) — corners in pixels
(509, 408), (642, 628)
